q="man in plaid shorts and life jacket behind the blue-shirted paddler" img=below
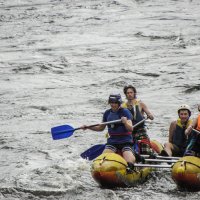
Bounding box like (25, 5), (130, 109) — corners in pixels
(122, 85), (154, 155)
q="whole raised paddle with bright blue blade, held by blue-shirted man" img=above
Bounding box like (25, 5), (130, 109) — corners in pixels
(51, 119), (121, 140)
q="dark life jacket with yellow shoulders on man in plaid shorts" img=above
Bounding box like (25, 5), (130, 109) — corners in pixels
(122, 99), (145, 131)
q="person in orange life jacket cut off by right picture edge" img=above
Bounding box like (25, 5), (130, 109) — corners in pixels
(184, 105), (200, 157)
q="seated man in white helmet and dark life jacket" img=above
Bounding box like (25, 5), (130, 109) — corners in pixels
(160, 104), (192, 157)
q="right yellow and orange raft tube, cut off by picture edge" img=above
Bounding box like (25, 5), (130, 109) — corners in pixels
(172, 156), (200, 191)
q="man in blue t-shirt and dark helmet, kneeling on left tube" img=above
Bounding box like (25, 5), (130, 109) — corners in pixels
(82, 94), (136, 171)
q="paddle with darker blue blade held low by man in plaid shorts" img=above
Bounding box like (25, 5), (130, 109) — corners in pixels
(80, 119), (147, 160)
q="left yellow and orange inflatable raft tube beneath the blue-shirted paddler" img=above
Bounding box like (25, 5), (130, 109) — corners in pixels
(91, 153), (152, 188)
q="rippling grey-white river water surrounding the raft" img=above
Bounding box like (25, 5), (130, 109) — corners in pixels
(0, 0), (200, 200)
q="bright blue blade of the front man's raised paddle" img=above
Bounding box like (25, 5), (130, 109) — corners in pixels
(51, 125), (74, 140)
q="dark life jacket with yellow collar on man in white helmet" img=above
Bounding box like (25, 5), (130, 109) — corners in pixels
(172, 118), (192, 149)
